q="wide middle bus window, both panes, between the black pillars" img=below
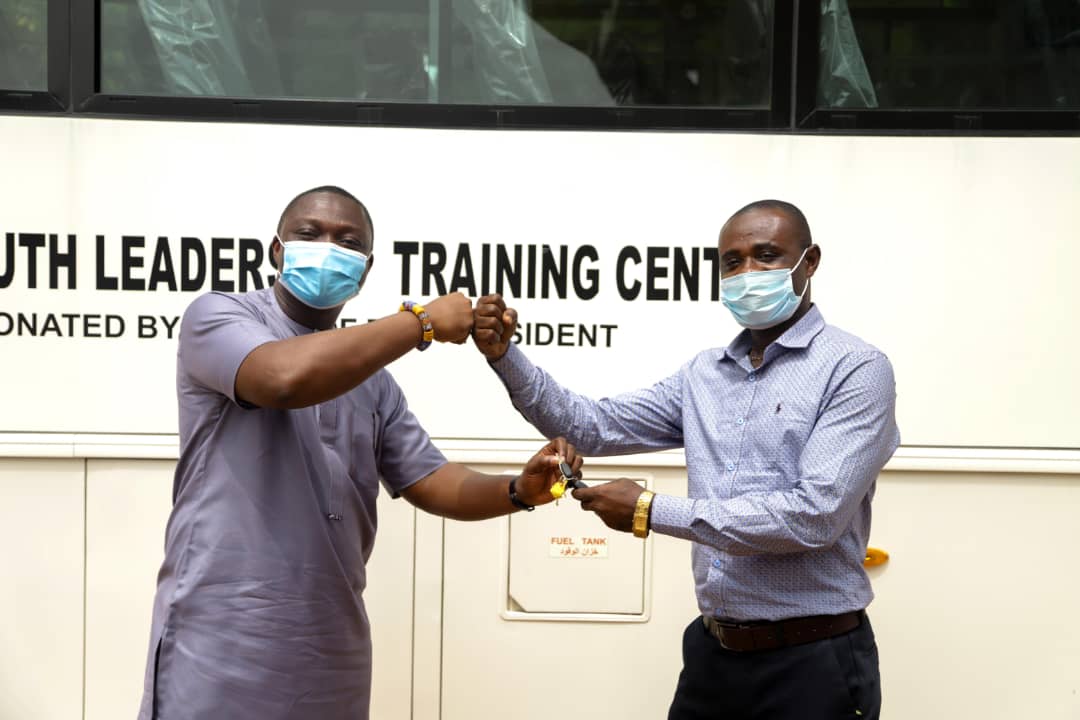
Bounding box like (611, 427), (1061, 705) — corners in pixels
(100, 0), (772, 108)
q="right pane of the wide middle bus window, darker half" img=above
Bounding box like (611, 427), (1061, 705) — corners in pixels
(448, 0), (772, 108)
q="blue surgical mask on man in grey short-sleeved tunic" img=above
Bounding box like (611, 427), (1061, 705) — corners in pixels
(279, 240), (367, 310)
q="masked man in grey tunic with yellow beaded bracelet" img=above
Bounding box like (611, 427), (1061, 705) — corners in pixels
(139, 187), (581, 720)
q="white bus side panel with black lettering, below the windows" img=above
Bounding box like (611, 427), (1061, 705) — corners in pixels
(0, 116), (1080, 720)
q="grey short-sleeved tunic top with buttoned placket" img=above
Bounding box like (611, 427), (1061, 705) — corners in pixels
(139, 288), (446, 720)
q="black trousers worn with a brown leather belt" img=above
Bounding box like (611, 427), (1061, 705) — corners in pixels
(667, 617), (881, 720)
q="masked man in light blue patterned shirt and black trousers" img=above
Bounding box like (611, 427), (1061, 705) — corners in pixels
(474, 200), (900, 720)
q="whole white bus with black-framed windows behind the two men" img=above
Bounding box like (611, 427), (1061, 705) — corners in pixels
(0, 0), (1080, 720)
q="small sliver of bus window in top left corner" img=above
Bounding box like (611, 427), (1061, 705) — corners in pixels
(0, 0), (49, 91)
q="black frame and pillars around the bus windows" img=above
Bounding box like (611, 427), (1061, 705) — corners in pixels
(0, 0), (1080, 136)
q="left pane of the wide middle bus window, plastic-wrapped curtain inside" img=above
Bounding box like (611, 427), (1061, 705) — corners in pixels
(100, 0), (437, 101)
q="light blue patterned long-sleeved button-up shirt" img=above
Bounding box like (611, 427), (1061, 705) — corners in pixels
(491, 305), (900, 621)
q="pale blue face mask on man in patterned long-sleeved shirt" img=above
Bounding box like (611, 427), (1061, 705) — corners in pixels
(720, 246), (812, 330)
